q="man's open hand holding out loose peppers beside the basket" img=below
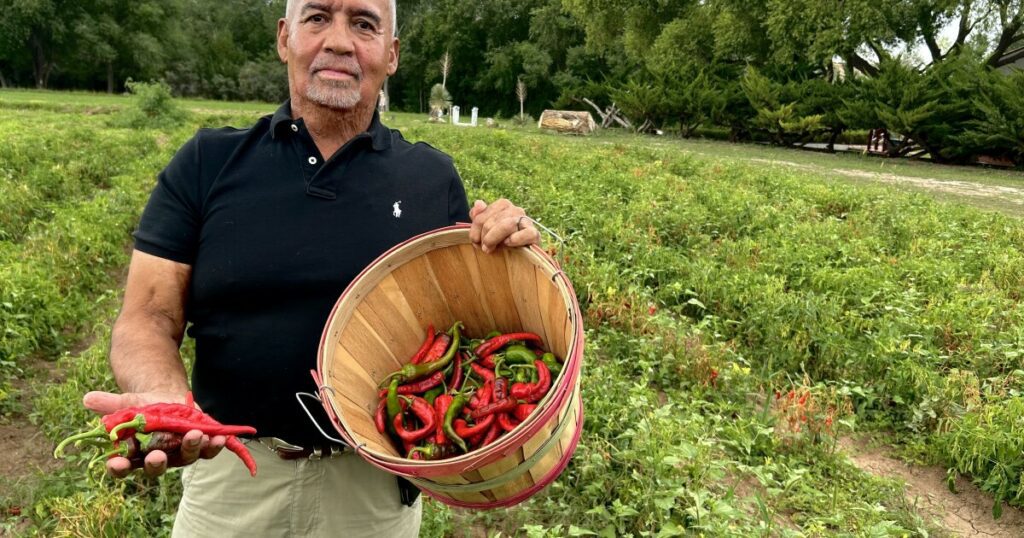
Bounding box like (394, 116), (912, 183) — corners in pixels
(82, 391), (227, 479)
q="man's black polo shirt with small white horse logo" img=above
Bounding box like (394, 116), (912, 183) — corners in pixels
(135, 102), (469, 444)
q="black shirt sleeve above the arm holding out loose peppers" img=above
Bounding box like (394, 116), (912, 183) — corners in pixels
(134, 134), (202, 265)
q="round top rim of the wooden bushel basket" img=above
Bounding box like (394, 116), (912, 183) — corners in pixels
(311, 223), (584, 467)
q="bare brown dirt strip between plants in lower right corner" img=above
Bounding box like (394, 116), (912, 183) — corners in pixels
(840, 439), (1024, 538)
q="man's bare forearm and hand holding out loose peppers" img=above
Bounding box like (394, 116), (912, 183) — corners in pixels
(82, 250), (225, 477)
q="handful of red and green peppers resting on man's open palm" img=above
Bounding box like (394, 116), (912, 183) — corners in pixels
(53, 392), (256, 477)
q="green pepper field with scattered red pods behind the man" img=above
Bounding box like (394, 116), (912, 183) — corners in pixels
(0, 92), (1024, 537)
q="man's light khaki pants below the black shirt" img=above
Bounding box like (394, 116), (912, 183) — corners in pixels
(172, 442), (422, 538)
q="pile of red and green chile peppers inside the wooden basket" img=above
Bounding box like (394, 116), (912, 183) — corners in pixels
(374, 322), (562, 460)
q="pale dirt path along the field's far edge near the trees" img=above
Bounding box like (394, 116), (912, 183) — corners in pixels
(750, 159), (1024, 208)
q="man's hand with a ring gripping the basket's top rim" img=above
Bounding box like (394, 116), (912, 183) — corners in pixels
(469, 198), (541, 252)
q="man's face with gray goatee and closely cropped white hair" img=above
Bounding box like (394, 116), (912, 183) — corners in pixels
(278, 0), (398, 110)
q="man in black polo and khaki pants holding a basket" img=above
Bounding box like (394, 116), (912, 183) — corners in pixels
(78, 0), (539, 536)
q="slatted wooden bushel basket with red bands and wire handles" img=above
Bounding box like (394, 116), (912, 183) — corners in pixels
(313, 225), (584, 508)
